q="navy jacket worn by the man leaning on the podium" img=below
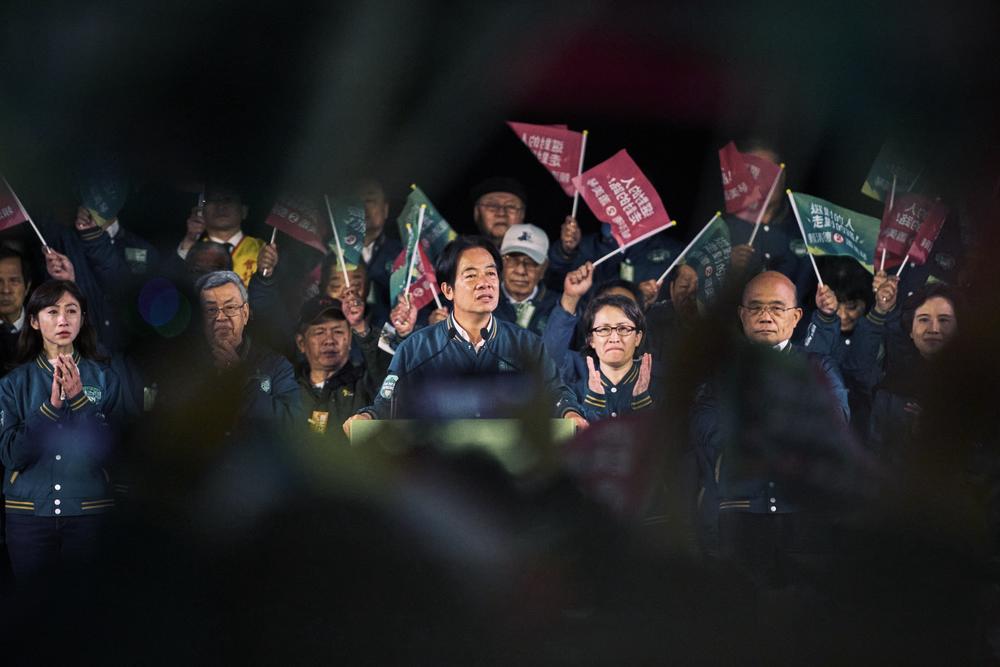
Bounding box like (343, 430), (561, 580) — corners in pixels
(360, 315), (583, 419)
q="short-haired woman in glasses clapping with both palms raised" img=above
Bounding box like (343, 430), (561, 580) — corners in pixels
(567, 294), (653, 421)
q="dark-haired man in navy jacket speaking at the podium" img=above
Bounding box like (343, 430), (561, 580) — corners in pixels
(344, 236), (587, 435)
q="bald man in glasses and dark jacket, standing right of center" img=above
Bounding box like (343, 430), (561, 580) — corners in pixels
(692, 271), (853, 586)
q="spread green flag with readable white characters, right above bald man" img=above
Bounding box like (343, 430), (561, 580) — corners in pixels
(787, 190), (882, 273)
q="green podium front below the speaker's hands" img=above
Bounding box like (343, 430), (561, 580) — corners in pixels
(351, 419), (575, 474)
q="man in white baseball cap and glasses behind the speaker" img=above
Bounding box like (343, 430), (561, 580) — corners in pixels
(494, 223), (560, 336)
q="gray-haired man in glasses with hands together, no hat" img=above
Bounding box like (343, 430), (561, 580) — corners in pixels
(195, 271), (301, 427)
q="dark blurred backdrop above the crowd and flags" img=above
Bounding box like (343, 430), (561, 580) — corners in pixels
(0, 0), (1000, 247)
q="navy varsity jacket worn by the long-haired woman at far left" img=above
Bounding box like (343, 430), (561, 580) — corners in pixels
(0, 354), (120, 517)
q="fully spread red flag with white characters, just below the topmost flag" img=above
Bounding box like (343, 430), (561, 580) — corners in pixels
(573, 150), (672, 246)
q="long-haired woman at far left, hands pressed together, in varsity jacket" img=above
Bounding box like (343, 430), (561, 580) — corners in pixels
(0, 280), (119, 582)
